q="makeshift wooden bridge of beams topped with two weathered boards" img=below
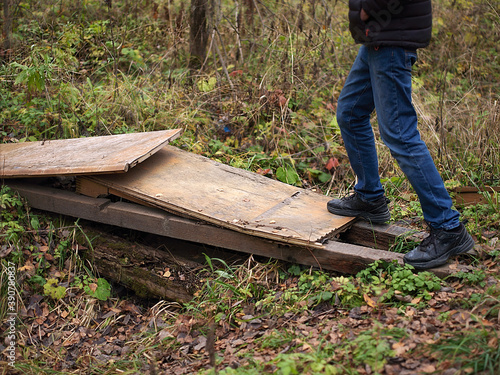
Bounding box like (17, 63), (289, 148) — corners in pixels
(0, 129), (462, 282)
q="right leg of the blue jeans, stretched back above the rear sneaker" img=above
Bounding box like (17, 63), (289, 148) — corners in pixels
(368, 47), (460, 229)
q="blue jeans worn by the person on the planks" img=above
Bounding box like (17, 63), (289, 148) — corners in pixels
(337, 45), (460, 229)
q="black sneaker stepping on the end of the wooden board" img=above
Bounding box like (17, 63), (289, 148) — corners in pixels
(327, 193), (391, 224)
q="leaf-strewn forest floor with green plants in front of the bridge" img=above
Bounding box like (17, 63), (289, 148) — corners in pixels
(0, 195), (500, 375)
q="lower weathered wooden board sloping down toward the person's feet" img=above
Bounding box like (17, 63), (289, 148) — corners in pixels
(83, 146), (354, 245)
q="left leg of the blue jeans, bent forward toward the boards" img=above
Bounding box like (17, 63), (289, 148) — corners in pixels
(337, 46), (384, 200)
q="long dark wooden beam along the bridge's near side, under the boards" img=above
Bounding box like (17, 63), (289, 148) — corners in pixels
(3, 180), (463, 277)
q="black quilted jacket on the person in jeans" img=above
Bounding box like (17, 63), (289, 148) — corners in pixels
(349, 0), (432, 49)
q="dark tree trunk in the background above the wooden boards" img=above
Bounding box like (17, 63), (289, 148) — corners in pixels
(189, 0), (209, 69)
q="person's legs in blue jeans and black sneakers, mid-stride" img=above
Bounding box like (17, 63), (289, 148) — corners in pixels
(328, 46), (474, 269)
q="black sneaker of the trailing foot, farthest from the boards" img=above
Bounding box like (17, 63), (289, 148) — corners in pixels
(403, 223), (474, 269)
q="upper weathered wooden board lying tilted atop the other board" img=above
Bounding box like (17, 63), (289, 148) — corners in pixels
(0, 129), (182, 178)
